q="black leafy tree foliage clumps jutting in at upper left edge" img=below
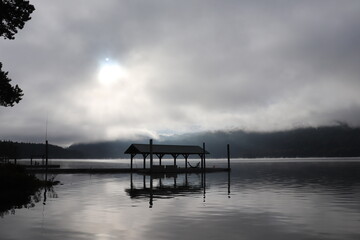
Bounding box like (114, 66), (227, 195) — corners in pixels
(0, 0), (35, 107)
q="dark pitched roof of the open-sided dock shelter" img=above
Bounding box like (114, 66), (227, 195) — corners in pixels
(125, 144), (210, 155)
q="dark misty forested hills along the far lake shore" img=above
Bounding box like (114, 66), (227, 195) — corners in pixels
(0, 126), (360, 158)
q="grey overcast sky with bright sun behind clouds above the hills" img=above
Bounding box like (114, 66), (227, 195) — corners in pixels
(0, 0), (360, 146)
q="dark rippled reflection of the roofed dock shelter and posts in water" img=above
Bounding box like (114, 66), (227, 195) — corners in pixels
(125, 172), (231, 208)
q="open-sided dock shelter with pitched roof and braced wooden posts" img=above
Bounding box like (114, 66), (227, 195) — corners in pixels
(125, 140), (210, 170)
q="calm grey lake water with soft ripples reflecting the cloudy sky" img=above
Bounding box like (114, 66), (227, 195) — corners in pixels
(0, 159), (360, 240)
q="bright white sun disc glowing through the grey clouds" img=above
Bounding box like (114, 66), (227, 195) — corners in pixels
(98, 63), (127, 86)
